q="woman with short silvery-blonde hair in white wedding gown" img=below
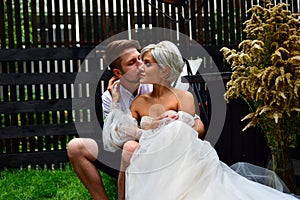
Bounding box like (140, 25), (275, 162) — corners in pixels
(103, 41), (296, 200)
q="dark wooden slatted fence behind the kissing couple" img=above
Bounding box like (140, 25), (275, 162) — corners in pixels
(0, 0), (299, 169)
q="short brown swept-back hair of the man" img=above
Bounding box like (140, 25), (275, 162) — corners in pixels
(103, 40), (141, 69)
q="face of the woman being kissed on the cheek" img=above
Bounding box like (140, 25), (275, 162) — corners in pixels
(140, 52), (162, 84)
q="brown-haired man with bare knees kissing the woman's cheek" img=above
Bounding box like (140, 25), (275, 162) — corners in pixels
(68, 40), (204, 200)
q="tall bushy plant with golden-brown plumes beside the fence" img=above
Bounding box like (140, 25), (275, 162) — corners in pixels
(221, 0), (300, 192)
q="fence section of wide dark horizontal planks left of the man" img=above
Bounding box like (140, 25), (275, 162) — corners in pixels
(0, 47), (109, 168)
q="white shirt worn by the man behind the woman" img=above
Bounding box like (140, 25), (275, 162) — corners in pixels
(102, 84), (153, 118)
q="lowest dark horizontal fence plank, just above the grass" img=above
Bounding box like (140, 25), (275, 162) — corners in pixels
(0, 150), (68, 169)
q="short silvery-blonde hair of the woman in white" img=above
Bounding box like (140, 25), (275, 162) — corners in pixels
(141, 41), (184, 83)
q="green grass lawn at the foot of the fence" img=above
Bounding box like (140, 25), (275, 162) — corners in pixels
(0, 166), (117, 200)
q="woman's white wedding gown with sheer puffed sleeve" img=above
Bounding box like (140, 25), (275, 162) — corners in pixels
(103, 108), (297, 200)
